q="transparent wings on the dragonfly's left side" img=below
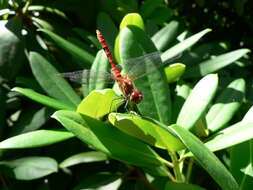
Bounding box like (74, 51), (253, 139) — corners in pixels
(57, 70), (114, 84)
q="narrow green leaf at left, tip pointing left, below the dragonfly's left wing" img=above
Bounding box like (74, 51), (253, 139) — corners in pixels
(12, 87), (75, 110)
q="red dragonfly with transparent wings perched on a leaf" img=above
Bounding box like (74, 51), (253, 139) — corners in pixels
(58, 30), (179, 105)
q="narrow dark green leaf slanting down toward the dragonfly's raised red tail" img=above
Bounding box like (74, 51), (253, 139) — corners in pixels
(38, 29), (94, 65)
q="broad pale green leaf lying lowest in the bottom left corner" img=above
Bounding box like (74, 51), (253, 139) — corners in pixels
(0, 156), (58, 180)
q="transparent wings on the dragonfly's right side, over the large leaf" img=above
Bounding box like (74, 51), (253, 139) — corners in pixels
(124, 52), (181, 79)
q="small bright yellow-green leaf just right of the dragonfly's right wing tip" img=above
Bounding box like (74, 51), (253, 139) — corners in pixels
(164, 63), (185, 83)
